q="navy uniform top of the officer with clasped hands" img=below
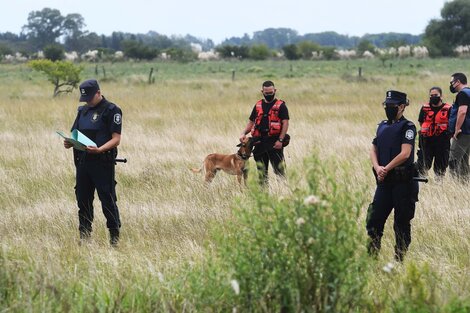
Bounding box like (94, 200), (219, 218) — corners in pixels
(372, 116), (416, 166)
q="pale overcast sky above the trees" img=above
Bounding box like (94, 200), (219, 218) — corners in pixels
(0, 0), (446, 44)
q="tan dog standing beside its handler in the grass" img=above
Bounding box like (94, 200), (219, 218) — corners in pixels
(192, 137), (253, 185)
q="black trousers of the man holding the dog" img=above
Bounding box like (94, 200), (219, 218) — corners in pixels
(253, 137), (285, 183)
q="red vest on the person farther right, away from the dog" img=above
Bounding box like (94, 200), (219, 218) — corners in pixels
(420, 103), (450, 137)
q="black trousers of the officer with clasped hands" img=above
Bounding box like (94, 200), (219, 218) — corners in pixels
(366, 182), (419, 261)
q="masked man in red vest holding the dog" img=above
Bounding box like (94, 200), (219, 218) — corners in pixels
(240, 80), (290, 184)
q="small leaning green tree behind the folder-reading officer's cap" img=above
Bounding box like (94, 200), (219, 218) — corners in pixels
(28, 60), (83, 97)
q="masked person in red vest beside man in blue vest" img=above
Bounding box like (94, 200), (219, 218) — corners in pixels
(417, 87), (451, 178)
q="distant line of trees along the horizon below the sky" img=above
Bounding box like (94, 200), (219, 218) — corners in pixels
(0, 0), (470, 61)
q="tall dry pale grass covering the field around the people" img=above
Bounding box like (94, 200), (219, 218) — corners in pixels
(0, 61), (470, 311)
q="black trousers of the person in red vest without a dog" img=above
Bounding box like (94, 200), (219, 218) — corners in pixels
(417, 135), (450, 176)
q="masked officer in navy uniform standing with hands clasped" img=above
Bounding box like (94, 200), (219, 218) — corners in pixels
(366, 90), (419, 262)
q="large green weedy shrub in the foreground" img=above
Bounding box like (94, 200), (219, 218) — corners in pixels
(184, 155), (366, 312)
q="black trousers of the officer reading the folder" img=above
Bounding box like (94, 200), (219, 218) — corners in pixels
(75, 160), (121, 232)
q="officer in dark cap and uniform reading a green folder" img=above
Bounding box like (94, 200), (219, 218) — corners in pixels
(64, 79), (122, 246)
